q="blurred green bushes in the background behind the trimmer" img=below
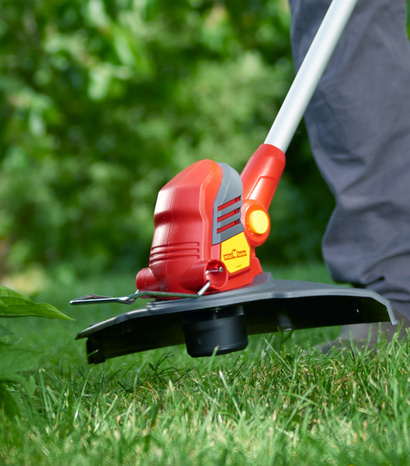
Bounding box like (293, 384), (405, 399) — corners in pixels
(0, 0), (348, 276)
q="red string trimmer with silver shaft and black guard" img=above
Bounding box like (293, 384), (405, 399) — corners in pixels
(71, 0), (397, 363)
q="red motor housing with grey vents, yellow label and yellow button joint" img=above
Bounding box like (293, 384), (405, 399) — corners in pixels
(136, 144), (285, 294)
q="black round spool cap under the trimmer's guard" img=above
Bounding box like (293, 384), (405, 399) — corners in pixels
(183, 306), (248, 358)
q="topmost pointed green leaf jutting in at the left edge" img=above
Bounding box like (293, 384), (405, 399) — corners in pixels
(0, 285), (74, 320)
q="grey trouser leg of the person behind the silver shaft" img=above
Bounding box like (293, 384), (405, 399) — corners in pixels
(290, 0), (410, 318)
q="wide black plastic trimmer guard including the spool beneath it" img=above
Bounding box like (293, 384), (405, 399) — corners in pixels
(77, 273), (397, 364)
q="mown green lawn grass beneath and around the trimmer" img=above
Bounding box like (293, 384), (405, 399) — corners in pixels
(0, 266), (410, 465)
